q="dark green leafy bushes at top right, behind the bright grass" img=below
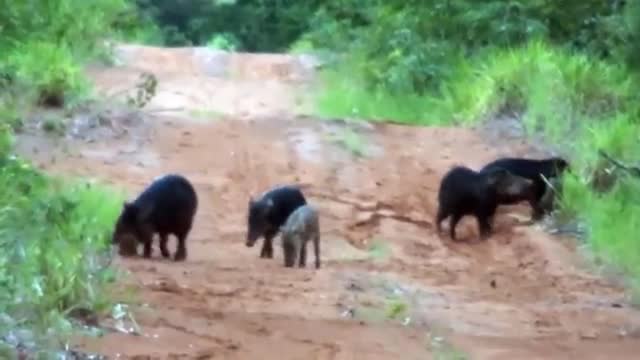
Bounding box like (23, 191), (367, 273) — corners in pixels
(303, 0), (640, 94)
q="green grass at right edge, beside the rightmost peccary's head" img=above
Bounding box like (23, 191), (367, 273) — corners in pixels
(561, 112), (640, 280)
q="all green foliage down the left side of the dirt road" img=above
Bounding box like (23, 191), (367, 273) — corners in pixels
(0, 0), (134, 358)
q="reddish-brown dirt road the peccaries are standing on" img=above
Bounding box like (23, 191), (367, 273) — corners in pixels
(20, 46), (640, 360)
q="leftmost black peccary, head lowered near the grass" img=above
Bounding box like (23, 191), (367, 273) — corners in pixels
(112, 174), (198, 261)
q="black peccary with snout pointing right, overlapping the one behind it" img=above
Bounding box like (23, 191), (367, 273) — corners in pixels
(435, 166), (533, 240)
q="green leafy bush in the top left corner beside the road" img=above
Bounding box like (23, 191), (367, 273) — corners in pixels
(0, 0), (134, 105)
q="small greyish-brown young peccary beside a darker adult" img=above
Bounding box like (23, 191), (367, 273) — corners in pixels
(280, 204), (320, 269)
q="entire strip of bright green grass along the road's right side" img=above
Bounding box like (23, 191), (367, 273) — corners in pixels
(316, 41), (640, 290)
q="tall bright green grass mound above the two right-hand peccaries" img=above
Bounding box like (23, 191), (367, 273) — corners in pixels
(432, 41), (637, 132)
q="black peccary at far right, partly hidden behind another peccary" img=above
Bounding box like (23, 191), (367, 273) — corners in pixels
(480, 157), (569, 221)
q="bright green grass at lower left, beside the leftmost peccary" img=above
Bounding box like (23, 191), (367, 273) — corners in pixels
(0, 143), (124, 350)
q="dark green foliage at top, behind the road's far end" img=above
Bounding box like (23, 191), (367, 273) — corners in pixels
(135, 0), (322, 52)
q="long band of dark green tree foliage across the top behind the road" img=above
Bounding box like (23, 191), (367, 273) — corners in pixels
(131, 0), (640, 93)
